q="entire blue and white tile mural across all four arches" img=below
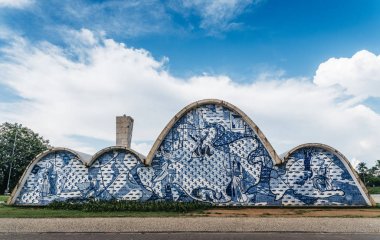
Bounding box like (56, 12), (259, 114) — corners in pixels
(13, 101), (371, 206)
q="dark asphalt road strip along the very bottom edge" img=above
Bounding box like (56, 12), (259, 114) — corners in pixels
(0, 233), (380, 240)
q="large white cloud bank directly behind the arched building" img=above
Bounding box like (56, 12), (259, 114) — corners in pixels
(0, 30), (380, 167)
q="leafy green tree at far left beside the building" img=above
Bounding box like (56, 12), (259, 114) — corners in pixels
(0, 122), (49, 193)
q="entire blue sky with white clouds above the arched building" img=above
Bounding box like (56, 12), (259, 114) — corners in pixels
(0, 0), (380, 165)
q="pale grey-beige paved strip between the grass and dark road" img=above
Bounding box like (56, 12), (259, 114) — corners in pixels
(0, 217), (380, 232)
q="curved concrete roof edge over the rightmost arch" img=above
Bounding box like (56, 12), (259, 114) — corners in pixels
(280, 143), (376, 206)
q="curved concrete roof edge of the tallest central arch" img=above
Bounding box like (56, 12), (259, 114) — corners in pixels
(145, 99), (282, 165)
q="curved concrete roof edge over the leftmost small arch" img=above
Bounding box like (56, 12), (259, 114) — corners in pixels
(7, 147), (86, 204)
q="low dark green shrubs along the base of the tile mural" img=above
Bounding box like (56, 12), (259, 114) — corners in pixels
(47, 200), (211, 213)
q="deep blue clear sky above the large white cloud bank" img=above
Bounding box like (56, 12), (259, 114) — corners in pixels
(0, 0), (380, 82)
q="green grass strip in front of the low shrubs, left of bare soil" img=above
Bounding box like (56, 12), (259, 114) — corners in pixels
(0, 205), (185, 218)
